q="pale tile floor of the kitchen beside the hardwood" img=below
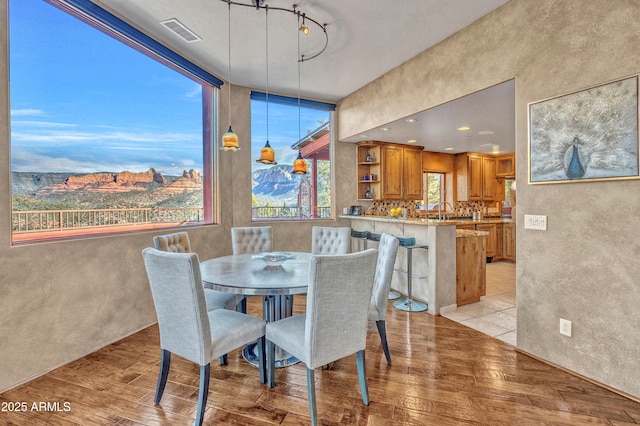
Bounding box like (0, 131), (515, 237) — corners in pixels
(443, 262), (516, 346)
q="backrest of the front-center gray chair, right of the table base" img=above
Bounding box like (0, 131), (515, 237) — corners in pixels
(304, 249), (378, 369)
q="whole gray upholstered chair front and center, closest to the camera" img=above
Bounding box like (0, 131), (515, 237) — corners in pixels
(265, 249), (378, 425)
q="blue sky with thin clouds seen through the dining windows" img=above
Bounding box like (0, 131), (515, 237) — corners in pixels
(10, 0), (328, 175)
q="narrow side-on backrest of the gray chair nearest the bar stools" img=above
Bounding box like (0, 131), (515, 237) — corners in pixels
(371, 234), (400, 321)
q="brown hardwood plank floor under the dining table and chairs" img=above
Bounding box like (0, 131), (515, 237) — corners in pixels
(0, 297), (640, 426)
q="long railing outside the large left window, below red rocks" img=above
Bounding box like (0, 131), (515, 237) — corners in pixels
(11, 208), (204, 234)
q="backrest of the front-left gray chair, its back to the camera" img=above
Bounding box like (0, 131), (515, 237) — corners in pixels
(142, 247), (211, 365)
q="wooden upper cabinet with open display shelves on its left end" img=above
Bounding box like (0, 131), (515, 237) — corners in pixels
(358, 141), (422, 200)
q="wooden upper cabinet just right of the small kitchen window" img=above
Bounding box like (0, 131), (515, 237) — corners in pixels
(456, 153), (503, 202)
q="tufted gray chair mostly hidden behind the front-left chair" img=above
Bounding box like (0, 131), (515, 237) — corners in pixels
(153, 232), (247, 313)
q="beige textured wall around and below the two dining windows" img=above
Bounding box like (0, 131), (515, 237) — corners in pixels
(0, 0), (356, 392)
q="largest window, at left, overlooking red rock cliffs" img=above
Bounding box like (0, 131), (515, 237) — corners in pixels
(9, 0), (219, 243)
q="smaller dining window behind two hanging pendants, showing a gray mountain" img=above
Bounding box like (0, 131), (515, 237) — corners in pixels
(251, 92), (335, 221)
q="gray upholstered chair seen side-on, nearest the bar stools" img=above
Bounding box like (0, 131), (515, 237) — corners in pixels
(369, 234), (400, 365)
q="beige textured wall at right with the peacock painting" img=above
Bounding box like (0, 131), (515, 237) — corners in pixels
(338, 0), (640, 397)
